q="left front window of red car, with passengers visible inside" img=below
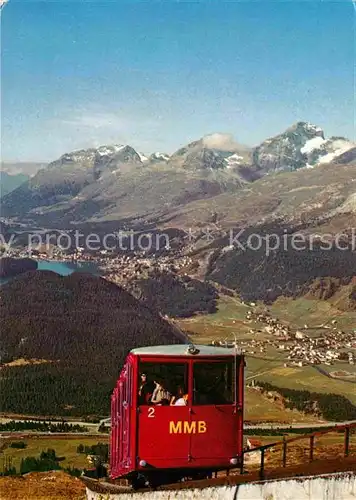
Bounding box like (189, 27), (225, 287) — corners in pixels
(138, 362), (188, 405)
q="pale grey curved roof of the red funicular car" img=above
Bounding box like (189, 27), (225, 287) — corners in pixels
(130, 344), (241, 357)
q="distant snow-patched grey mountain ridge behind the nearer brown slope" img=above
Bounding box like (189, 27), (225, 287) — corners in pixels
(1, 122), (356, 224)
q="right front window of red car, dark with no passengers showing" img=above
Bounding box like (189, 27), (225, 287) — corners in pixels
(193, 361), (235, 405)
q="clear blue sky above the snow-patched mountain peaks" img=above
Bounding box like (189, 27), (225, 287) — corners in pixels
(1, 0), (355, 161)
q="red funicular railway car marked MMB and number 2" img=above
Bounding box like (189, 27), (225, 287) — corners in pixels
(110, 344), (245, 489)
